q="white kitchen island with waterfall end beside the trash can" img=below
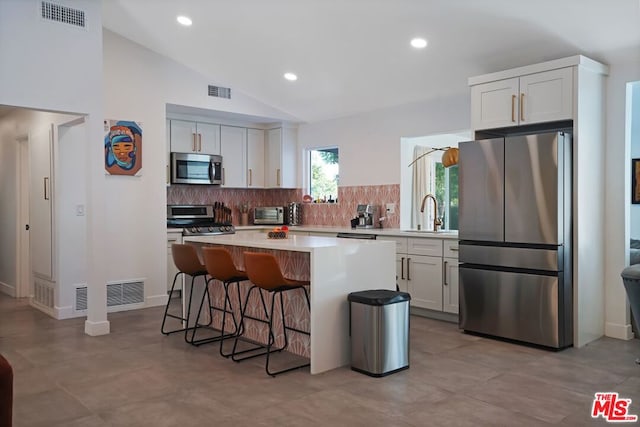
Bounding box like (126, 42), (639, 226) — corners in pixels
(184, 231), (396, 374)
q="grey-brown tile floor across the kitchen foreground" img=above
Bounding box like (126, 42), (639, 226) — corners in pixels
(0, 294), (640, 427)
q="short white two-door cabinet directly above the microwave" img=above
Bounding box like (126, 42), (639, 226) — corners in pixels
(171, 120), (220, 154)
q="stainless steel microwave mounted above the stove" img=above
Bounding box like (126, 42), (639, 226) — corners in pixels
(171, 153), (222, 185)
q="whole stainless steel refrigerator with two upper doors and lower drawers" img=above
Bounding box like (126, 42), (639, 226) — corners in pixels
(459, 132), (572, 348)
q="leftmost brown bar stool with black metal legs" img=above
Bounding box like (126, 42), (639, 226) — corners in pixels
(160, 243), (208, 342)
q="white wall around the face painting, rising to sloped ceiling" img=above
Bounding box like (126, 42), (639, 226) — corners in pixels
(103, 30), (302, 305)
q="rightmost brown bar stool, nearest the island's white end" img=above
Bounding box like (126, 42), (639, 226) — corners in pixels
(234, 252), (311, 377)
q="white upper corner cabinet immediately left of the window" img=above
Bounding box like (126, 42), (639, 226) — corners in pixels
(265, 127), (298, 188)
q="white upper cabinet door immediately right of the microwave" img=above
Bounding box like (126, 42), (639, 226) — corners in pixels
(220, 126), (247, 188)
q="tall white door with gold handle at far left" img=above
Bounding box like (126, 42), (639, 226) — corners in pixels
(29, 125), (54, 280)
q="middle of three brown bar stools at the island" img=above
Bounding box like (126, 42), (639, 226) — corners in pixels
(190, 247), (249, 357)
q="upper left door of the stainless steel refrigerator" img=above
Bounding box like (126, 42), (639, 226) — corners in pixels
(458, 138), (504, 241)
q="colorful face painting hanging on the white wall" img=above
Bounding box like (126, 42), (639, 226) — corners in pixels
(104, 120), (142, 175)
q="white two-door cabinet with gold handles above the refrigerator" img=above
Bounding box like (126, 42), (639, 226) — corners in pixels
(469, 67), (573, 130)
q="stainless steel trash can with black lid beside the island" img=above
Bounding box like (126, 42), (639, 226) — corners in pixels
(349, 289), (411, 377)
